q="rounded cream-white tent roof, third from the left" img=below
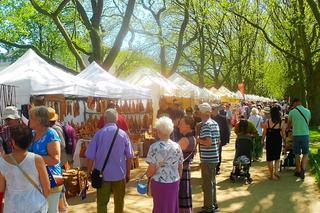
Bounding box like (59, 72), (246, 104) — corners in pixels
(126, 68), (186, 97)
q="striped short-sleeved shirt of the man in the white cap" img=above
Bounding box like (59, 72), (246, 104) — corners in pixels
(200, 118), (220, 163)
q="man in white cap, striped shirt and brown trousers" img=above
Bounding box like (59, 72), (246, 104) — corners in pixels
(197, 103), (220, 213)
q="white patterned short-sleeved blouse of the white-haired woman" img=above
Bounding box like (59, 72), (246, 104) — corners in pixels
(146, 139), (183, 183)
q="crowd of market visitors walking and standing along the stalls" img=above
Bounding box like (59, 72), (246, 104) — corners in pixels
(0, 96), (311, 213)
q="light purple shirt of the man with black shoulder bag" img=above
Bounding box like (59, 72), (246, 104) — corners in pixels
(86, 124), (134, 181)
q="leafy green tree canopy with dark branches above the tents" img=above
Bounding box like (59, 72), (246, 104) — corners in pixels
(0, 0), (320, 123)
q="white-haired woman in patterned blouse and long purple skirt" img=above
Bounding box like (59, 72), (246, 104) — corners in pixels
(146, 117), (183, 213)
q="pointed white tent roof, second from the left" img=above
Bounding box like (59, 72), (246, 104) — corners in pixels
(77, 62), (151, 99)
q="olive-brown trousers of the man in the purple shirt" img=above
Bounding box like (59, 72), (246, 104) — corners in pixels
(97, 179), (126, 213)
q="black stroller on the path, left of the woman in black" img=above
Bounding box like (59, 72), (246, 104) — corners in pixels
(230, 136), (253, 184)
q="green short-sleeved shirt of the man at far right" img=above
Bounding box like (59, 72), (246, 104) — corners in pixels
(289, 105), (311, 136)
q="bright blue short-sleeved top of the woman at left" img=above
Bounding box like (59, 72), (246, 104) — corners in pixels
(29, 128), (62, 175)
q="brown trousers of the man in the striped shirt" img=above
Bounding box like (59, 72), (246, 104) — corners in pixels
(201, 163), (217, 211)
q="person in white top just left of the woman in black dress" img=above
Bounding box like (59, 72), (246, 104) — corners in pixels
(248, 108), (263, 161)
